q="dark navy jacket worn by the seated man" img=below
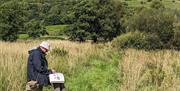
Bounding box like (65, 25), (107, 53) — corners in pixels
(27, 48), (52, 85)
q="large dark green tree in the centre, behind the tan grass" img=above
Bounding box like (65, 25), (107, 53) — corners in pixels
(68, 0), (123, 42)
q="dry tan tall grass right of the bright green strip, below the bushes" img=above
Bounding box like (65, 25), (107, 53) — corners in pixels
(121, 49), (180, 91)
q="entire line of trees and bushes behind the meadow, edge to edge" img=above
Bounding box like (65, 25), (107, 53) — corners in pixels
(0, 0), (180, 49)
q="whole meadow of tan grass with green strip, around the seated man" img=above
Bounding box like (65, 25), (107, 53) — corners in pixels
(0, 40), (180, 91)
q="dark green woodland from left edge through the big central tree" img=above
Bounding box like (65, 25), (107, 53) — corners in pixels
(0, 0), (124, 42)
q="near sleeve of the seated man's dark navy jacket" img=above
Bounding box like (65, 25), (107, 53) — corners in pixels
(33, 52), (51, 74)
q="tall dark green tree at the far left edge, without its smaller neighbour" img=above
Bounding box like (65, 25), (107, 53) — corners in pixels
(0, 0), (27, 41)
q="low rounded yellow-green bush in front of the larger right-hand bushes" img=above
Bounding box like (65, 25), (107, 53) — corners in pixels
(112, 31), (163, 50)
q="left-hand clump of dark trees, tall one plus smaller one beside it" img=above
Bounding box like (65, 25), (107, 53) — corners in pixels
(0, 0), (47, 41)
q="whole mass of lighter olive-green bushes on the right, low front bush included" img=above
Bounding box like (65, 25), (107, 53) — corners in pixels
(113, 1), (180, 49)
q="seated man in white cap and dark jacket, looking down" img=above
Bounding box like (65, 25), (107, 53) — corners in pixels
(26, 41), (55, 91)
